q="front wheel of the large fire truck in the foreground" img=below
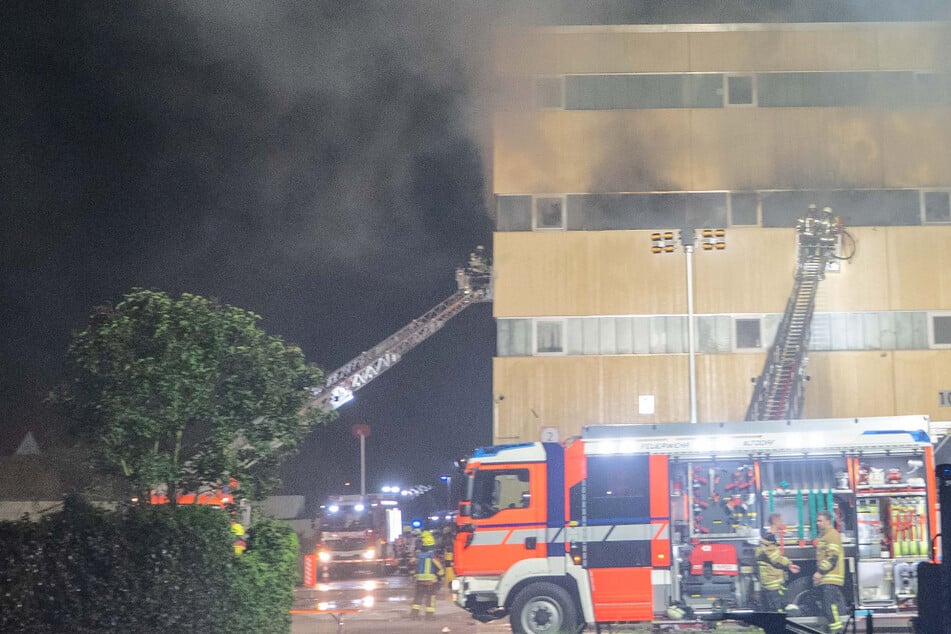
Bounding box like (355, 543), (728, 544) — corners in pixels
(510, 582), (583, 634)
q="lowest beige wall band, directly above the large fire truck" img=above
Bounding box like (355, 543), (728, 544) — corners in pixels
(493, 350), (951, 442)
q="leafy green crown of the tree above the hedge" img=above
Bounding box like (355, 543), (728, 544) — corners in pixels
(51, 289), (330, 500)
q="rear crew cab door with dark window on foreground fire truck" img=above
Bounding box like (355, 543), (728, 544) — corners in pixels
(570, 454), (670, 622)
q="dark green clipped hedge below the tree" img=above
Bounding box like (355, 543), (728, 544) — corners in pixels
(0, 498), (297, 634)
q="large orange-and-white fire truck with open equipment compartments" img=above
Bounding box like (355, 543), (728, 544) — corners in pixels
(454, 416), (937, 634)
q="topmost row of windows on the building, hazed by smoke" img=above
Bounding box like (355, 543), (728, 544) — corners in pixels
(533, 71), (951, 110)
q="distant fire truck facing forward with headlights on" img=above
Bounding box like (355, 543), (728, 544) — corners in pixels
(317, 494), (402, 577)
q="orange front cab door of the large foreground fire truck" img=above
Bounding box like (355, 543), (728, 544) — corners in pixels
(455, 462), (548, 575)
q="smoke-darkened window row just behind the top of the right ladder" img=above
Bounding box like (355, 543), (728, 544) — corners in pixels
(496, 189), (951, 236)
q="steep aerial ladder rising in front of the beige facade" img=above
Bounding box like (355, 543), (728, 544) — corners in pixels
(746, 205), (851, 421)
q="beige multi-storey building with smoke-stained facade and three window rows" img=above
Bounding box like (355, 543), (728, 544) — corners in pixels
(493, 22), (951, 442)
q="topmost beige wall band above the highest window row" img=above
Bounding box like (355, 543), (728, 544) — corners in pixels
(495, 22), (951, 75)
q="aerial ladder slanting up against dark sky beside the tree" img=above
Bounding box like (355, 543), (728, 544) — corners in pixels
(307, 246), (492, 412)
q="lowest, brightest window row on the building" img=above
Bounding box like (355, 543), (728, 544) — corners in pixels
(496, 311), (951, 357)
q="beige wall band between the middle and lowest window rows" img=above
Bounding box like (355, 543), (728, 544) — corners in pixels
(494, 225), (951, 317)
